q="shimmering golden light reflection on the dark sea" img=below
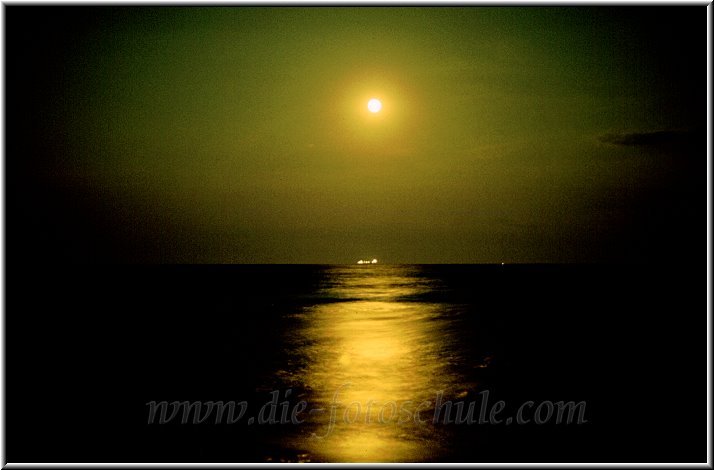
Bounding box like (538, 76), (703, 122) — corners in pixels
(262, 266), (490, 462)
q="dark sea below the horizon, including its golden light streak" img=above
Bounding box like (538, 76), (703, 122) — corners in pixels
(6, 265), (706, 462)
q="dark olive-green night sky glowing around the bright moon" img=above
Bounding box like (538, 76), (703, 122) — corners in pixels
(4, 6), (707, 263)
